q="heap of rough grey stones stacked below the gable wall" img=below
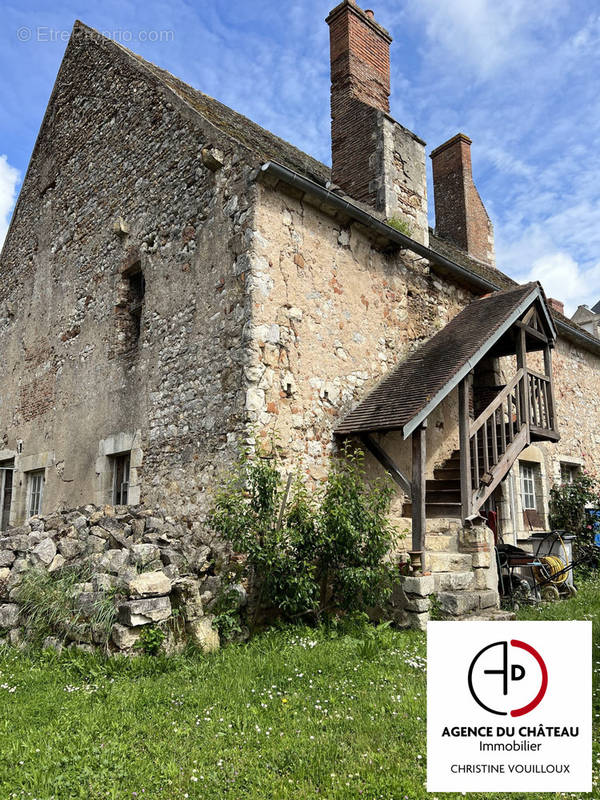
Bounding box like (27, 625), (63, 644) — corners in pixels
(0, 505), (246, 652)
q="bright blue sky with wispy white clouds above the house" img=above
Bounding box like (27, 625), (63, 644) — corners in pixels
(0, 0), (600, 313)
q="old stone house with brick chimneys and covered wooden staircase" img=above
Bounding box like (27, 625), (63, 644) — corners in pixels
(0, 0), (600, 616)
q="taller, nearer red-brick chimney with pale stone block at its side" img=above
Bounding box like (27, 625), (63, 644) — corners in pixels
(326, 0), (428, 244)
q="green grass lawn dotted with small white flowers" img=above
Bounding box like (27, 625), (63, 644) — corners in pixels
(0, 580), (600, 800)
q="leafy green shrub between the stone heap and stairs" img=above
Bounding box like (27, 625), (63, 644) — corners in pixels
(211, 440), (395, 625)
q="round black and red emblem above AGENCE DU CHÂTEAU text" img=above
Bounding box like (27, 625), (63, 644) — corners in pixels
(468, 639), (548, 717)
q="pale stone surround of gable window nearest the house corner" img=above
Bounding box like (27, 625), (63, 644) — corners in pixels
(96, 430), (144, 506)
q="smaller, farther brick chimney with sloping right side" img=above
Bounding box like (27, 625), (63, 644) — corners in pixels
(431, 133), (496, 265)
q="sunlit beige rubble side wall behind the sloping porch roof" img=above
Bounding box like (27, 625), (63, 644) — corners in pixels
(247, 180), (470, 524)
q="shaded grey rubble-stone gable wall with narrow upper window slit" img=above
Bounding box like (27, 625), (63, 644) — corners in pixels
(0, 26), (252, 525)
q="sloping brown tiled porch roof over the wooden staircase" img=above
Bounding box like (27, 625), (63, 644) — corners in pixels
(335, 282), (556, 438)
